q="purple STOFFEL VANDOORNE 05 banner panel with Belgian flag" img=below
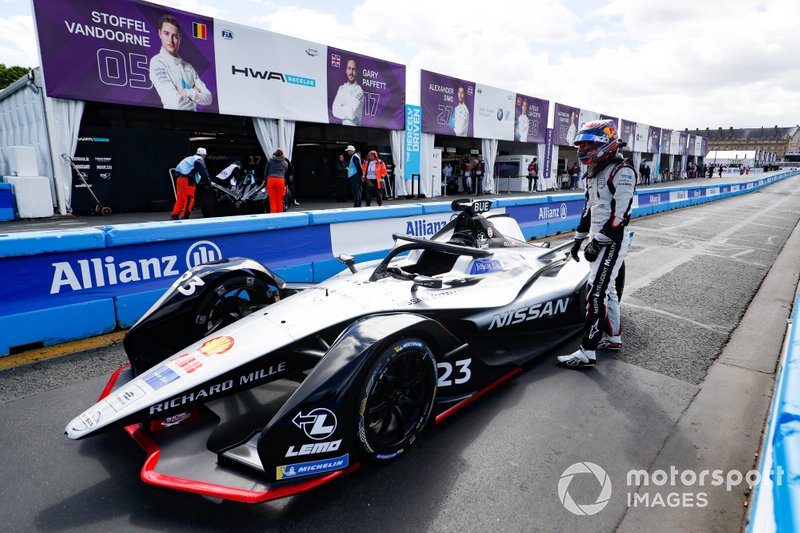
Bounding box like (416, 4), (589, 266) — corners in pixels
(33, 0), (218, 112)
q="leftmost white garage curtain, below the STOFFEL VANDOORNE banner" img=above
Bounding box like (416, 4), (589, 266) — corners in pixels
(45, 98), (86, 215)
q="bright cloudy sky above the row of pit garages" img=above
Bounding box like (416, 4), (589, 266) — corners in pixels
(0, 0), (800, 129)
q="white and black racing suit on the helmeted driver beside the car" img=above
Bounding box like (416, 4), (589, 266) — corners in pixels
(575, 157), (636, 350)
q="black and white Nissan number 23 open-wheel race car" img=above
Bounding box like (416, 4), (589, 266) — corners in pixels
(65, 200), (589, 503)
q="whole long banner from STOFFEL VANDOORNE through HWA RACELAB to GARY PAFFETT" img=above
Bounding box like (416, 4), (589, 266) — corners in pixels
(33, 0), (405, 129)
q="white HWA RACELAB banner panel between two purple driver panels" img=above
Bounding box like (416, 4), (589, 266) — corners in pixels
(215, 20), (328, 122)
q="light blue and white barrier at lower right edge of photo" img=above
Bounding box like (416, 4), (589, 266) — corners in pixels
(748, 280), (800, 533)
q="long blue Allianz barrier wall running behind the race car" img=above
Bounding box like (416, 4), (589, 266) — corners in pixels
(0, 171), (800, 355)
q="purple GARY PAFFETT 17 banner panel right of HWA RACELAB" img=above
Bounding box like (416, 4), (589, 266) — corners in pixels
(327, 48), (406, 130)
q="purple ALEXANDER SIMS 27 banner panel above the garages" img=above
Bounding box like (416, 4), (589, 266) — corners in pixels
(419, 70), (475, 137)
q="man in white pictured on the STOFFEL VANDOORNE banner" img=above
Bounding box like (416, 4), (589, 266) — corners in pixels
(150, 15), (212, 111)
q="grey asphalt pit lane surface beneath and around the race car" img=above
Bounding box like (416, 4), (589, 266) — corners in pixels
(0, 177), (800, 531)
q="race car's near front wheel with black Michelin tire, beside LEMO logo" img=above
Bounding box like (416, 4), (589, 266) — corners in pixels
(356, 338), (436, 461)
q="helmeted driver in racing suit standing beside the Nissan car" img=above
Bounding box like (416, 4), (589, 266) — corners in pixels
(558, 120), (636, 368)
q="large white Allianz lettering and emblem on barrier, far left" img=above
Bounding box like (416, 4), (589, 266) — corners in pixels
(50, 241), (222, 294)
